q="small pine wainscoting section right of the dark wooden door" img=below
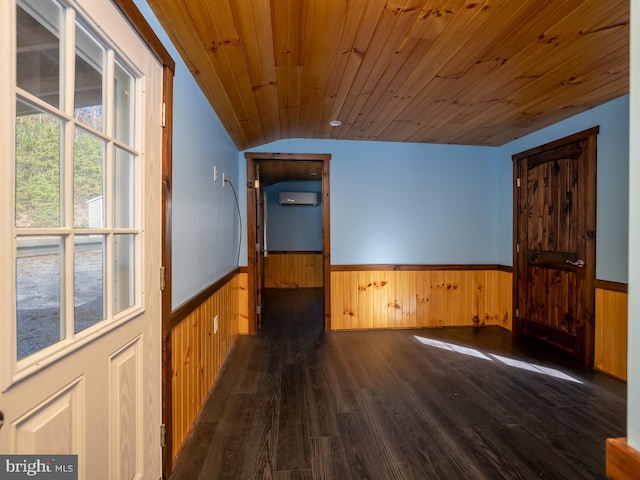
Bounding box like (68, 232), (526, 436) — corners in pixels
(593, 288), (627, 380)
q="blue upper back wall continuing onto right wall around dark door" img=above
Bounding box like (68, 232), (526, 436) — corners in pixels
(246, 96), (629, 283)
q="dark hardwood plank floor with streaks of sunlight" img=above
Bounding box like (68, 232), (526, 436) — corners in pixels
(172, 289), (626, 480)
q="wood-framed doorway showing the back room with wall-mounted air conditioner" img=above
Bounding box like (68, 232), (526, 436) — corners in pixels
(245, 153), (331, 334)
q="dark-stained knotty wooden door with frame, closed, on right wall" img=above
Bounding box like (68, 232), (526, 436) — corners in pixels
(513, 128), (598, 366)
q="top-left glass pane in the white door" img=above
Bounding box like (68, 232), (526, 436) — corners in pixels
(16, 0), (62, 108)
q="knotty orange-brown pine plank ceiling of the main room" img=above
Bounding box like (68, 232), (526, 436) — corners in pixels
(148, 0), (629, 150)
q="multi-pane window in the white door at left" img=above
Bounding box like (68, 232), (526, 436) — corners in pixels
(14, 0), (141, 361)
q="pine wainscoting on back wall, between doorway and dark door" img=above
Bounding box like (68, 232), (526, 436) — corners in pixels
(331, 268), (512, 330)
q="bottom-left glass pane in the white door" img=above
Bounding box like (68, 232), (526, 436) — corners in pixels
(16, 237), (64, 360)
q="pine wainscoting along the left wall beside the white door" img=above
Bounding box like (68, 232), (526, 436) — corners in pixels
(171, 274), (240, 460)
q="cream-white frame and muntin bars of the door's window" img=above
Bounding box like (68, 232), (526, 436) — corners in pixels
(0, 0), (145, 391)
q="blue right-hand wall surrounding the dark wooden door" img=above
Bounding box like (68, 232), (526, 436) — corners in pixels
(498, 96), (629, 283)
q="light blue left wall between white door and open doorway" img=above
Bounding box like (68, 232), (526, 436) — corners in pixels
(135, 0), (241, 308)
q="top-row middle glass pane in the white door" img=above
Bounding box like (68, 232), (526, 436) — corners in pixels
(73, 25), (104, 130)
